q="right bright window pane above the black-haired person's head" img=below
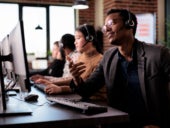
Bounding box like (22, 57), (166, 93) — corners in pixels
(50, 6), (75, 49)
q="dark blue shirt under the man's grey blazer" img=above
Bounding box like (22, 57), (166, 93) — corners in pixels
(118, 46), (147, 125)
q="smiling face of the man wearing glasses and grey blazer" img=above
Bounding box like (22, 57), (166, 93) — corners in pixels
(103, 13), (127, 46)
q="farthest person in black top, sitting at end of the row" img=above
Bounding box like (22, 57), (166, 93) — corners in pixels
(30, 41), (65, 80)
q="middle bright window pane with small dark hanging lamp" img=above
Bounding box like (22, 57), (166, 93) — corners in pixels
(23, 7), (47, 58)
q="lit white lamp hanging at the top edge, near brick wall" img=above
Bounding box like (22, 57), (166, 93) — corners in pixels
(72, 0), (89, 9)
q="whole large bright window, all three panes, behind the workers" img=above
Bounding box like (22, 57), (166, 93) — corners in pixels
(0, 3), (75, 58)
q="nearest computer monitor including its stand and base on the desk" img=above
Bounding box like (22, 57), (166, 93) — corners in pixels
(0, 20), (31, 115)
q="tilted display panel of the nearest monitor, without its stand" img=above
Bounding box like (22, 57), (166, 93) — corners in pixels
(9, 20), (31, 92)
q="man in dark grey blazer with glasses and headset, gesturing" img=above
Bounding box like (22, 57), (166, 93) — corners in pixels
(70, 9), (170, 128)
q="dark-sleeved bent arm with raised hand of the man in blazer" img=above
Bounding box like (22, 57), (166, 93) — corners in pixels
(70, 63), (105, 98)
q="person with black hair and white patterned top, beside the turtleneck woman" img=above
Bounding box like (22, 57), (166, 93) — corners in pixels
(33, 33), (80, 85)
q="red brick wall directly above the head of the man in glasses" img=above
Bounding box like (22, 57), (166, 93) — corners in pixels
(103, 0), (158, 49)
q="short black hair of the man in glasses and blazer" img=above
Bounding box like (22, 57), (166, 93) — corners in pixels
(107, 8), (137, 35)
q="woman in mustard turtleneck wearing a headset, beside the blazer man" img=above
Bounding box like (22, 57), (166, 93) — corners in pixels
(43, 24), (106, 100)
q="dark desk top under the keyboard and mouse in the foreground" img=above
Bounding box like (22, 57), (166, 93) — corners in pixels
(0, 87), (128, 128)
